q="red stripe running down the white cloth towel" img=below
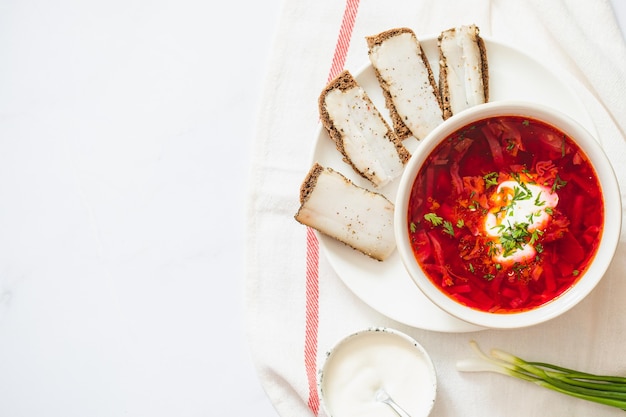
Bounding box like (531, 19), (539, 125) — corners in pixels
(304, 0), (359, 416)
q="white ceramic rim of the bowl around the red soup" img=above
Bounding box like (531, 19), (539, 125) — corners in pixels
(394, 101), (622, 328)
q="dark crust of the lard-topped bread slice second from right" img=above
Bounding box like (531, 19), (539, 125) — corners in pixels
(365, 27), (443, 140)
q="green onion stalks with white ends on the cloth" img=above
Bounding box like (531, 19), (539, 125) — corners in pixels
(456, 341), (626, 411)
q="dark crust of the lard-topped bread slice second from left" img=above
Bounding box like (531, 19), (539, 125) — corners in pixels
(318, 70), (411, 184)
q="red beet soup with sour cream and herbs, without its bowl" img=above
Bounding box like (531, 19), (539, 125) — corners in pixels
(407, 116), (604, 313)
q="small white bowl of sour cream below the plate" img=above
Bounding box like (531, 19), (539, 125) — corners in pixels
(318, 328), (437, 417)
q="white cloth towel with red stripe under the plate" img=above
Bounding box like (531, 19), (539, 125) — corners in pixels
(246, 0), (626, 417)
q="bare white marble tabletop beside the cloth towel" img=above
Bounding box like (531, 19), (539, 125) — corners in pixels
(0, 0), (626, 417)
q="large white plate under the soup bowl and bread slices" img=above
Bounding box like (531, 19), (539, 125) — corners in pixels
(313, 37), (595, 332)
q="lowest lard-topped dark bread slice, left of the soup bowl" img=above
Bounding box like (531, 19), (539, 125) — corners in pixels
(295, 164), (396, 261)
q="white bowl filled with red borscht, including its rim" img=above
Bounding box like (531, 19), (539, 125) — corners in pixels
(394, 101), (621, 328)
